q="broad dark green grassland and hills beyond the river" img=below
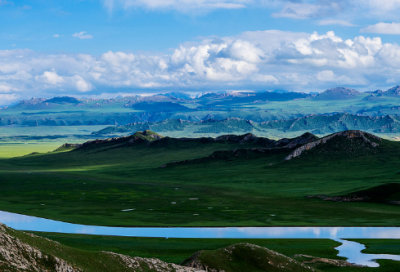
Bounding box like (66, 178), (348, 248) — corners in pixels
(0, 129), (400, 226)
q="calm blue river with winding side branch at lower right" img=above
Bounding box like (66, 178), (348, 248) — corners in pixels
(0, 211), (400, 267)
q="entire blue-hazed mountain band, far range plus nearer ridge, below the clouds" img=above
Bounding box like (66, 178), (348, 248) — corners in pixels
(0, 86), (400, 135)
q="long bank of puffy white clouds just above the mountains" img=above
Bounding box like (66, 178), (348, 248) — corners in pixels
(0, 30), (400, 101)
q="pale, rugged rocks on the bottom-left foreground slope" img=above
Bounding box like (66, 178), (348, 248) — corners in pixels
(0, 223), (205, 272)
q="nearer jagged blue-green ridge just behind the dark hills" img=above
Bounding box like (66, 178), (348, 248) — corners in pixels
(92, 114), (400, 135)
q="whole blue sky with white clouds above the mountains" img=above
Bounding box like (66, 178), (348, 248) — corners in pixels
(0, 0), (400, 105)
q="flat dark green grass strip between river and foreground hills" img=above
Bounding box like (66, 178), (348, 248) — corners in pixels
(26, 232), (400, 272)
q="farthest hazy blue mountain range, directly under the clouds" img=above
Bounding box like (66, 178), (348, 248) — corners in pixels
(0, 87), (400, 130)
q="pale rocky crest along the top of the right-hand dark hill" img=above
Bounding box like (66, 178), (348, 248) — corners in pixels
(285, 130), (382, 161)
